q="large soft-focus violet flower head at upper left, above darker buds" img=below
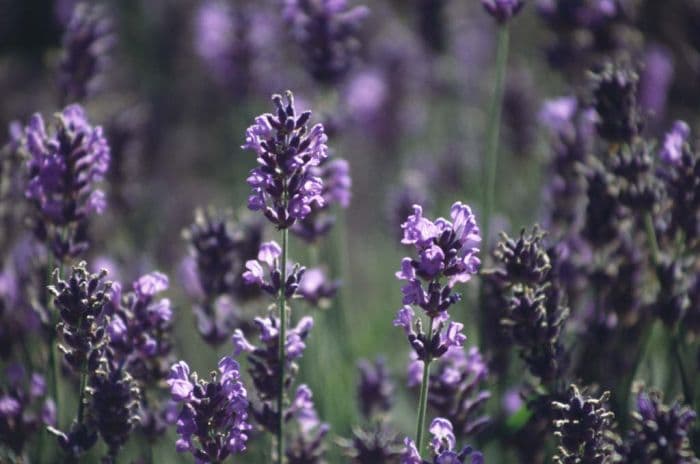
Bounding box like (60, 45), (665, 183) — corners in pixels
(25, 105), (110, 260)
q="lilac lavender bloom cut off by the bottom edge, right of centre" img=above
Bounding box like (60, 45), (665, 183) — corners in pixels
(401, 417), (484, 464)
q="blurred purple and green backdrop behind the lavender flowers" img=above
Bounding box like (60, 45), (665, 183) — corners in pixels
(0, 0), (700, 462)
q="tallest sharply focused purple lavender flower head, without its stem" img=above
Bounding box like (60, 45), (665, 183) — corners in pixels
(243, 91), (328, 229)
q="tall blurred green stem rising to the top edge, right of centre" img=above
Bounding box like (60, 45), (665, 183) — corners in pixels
(481, 24), (510, 250)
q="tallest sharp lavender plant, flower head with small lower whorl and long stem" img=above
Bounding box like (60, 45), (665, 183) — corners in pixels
(243, 91), (328, 463)
